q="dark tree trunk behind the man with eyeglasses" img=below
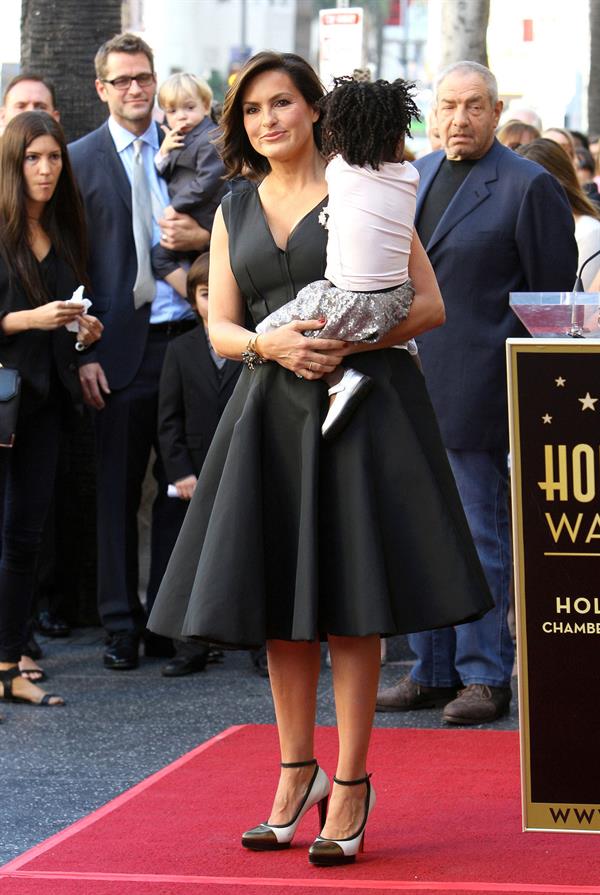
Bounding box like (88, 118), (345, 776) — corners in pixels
(21, 0), (121, 141)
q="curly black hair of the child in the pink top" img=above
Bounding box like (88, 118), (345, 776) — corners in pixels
(319, 76), (421, 169)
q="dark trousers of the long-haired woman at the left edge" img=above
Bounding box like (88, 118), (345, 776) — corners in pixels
(0, 399), (61, 662)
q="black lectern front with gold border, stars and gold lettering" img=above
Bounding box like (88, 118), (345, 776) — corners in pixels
(507, 339), (600, 833)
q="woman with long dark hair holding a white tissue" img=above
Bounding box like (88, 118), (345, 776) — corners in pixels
(0, 112), (102, 706)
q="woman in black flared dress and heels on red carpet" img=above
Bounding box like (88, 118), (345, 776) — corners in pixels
(149, 52), (491, 864)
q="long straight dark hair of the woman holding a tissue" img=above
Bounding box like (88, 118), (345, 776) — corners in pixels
(0, 112), (89, 305)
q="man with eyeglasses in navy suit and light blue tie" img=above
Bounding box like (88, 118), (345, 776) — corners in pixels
(69, 33), (210, 670)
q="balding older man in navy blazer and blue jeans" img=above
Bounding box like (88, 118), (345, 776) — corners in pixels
(378, 62), (577, 724)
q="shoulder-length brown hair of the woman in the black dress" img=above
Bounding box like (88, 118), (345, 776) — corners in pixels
(217, 50), (325, 180)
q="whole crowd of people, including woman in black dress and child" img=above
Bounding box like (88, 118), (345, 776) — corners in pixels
(0, 33), (600, 865)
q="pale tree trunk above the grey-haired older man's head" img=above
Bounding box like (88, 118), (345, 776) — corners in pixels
(441, 0), (490, 68)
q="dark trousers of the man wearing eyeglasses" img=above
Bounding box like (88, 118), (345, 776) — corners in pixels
(96, 329), (188, 635)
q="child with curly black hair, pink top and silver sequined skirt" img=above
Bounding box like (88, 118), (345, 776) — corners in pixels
(254, 77), (419, 438)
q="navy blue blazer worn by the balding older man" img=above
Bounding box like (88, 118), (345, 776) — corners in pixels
(414, 141), (577, 450)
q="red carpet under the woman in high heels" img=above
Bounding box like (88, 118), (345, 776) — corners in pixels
(0, 726), (600, 895)
